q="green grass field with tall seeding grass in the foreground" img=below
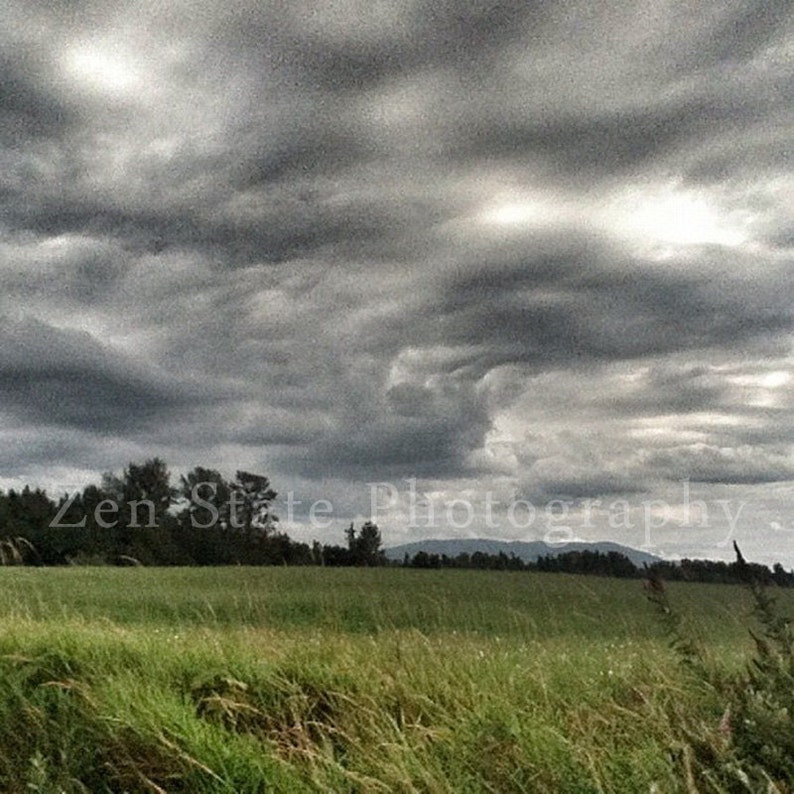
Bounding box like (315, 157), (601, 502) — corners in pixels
(0, 568), (794, 793)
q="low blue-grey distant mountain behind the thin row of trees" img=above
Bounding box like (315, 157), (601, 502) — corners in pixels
(385, 538), (662, 568)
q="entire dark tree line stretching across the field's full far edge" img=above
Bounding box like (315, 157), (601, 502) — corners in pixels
(0, 458), (794, 587)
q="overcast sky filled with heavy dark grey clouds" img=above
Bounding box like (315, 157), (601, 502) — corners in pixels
(0, 0), (794, 567)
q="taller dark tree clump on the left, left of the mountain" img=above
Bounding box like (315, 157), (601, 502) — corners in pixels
(0, 458), (385, 565)
